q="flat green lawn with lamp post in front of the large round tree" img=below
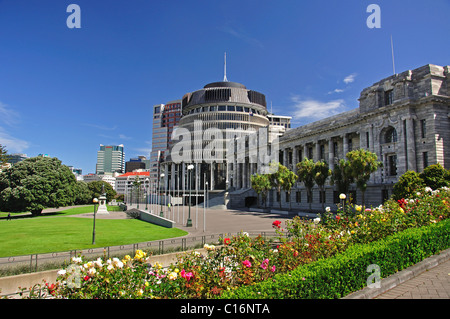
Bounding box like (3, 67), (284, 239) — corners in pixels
(0, 206), (187, 257)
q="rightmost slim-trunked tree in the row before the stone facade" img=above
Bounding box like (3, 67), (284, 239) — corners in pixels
(346, 149), (383, 207)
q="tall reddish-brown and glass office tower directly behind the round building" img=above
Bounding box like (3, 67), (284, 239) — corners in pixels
(150, 100), (181, 182)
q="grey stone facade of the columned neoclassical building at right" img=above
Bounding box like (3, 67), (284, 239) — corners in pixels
(231, 64), (450, 210)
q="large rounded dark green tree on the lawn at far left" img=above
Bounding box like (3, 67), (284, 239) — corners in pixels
(0, 157), (76, 216)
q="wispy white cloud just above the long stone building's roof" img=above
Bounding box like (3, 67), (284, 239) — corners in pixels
(291, 96), (345, 121)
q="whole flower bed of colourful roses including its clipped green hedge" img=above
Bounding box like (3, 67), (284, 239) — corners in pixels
(42, 188), (450, 299)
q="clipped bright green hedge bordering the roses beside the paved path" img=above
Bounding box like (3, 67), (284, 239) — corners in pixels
(220, 219), (450, 299)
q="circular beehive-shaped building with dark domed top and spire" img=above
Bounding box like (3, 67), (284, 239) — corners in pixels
(164, 81), (269, 195)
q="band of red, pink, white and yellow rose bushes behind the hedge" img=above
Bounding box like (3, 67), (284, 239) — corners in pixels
(46, 187), (450, 299)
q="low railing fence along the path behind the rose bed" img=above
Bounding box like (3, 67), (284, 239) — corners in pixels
(0, 232), (279, 276)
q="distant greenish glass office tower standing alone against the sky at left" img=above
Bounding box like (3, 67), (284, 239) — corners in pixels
(96, 144), (125, 175)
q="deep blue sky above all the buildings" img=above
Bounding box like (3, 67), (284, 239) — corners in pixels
(0, 0), (450, 174)
